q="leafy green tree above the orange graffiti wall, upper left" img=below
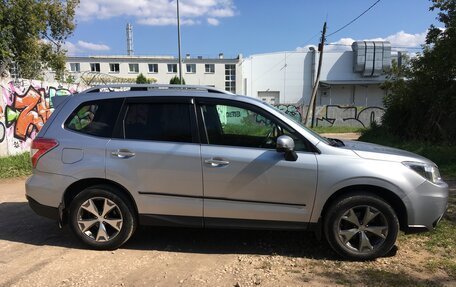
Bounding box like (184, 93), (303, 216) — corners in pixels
(0, 0), (79, 80)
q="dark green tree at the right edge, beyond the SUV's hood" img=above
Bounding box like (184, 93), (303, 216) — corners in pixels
(383, 0), (456, 143)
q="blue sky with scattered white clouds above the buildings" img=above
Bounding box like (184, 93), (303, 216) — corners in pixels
(66, 0), (442, 58)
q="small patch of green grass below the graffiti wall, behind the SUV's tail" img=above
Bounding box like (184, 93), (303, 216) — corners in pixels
(0, 152), (32, 178)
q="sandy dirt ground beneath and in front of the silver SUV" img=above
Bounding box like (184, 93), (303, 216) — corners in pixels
(0, 180), (456, 286)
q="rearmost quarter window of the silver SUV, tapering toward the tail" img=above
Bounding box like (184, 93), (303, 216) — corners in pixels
(65, 99), (123, 137)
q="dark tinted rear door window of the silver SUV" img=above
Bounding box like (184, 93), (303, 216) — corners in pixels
(124, 103), (192, 143)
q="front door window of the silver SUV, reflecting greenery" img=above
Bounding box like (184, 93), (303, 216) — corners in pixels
(201, 104), (308, 151)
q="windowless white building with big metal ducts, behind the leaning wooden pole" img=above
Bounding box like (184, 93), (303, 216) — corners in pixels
(240, 42), (391, 107)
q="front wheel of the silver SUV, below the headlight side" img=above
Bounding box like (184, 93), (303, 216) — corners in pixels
(323, 193), (399, 261)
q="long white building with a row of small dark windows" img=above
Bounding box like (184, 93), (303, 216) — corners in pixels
(66, 54), (242, 94)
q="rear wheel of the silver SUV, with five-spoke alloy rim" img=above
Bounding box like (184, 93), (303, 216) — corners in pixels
(69, 185), (137, 250)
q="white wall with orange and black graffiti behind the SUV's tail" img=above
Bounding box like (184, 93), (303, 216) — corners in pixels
(0, 79), (84, 156)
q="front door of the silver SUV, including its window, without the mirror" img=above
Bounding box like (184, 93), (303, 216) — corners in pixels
(198, 99), (317, 228)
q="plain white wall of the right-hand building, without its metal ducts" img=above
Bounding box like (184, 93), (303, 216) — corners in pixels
(241, 51), (385, 107)
